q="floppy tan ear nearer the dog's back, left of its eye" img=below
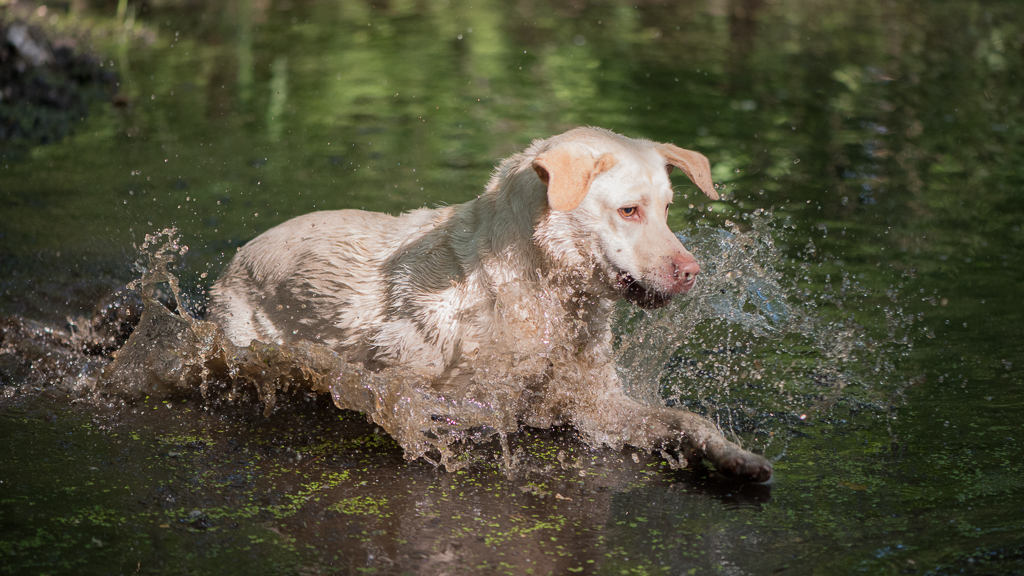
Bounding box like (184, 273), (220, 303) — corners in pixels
(534, 147), (615, 212)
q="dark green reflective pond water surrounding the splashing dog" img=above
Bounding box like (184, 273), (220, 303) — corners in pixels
(0, 0), (1024, 574)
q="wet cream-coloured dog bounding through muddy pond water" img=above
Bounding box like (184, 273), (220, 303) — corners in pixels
(209, 127), (772, 482)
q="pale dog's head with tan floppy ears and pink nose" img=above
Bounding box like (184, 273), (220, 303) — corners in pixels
(532, 128), (718, 308)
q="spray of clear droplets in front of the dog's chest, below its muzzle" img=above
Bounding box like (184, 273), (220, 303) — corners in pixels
(616, 211), (911, 449)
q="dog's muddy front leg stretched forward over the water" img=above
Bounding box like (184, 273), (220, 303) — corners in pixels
(575, 366), (772, 482)
